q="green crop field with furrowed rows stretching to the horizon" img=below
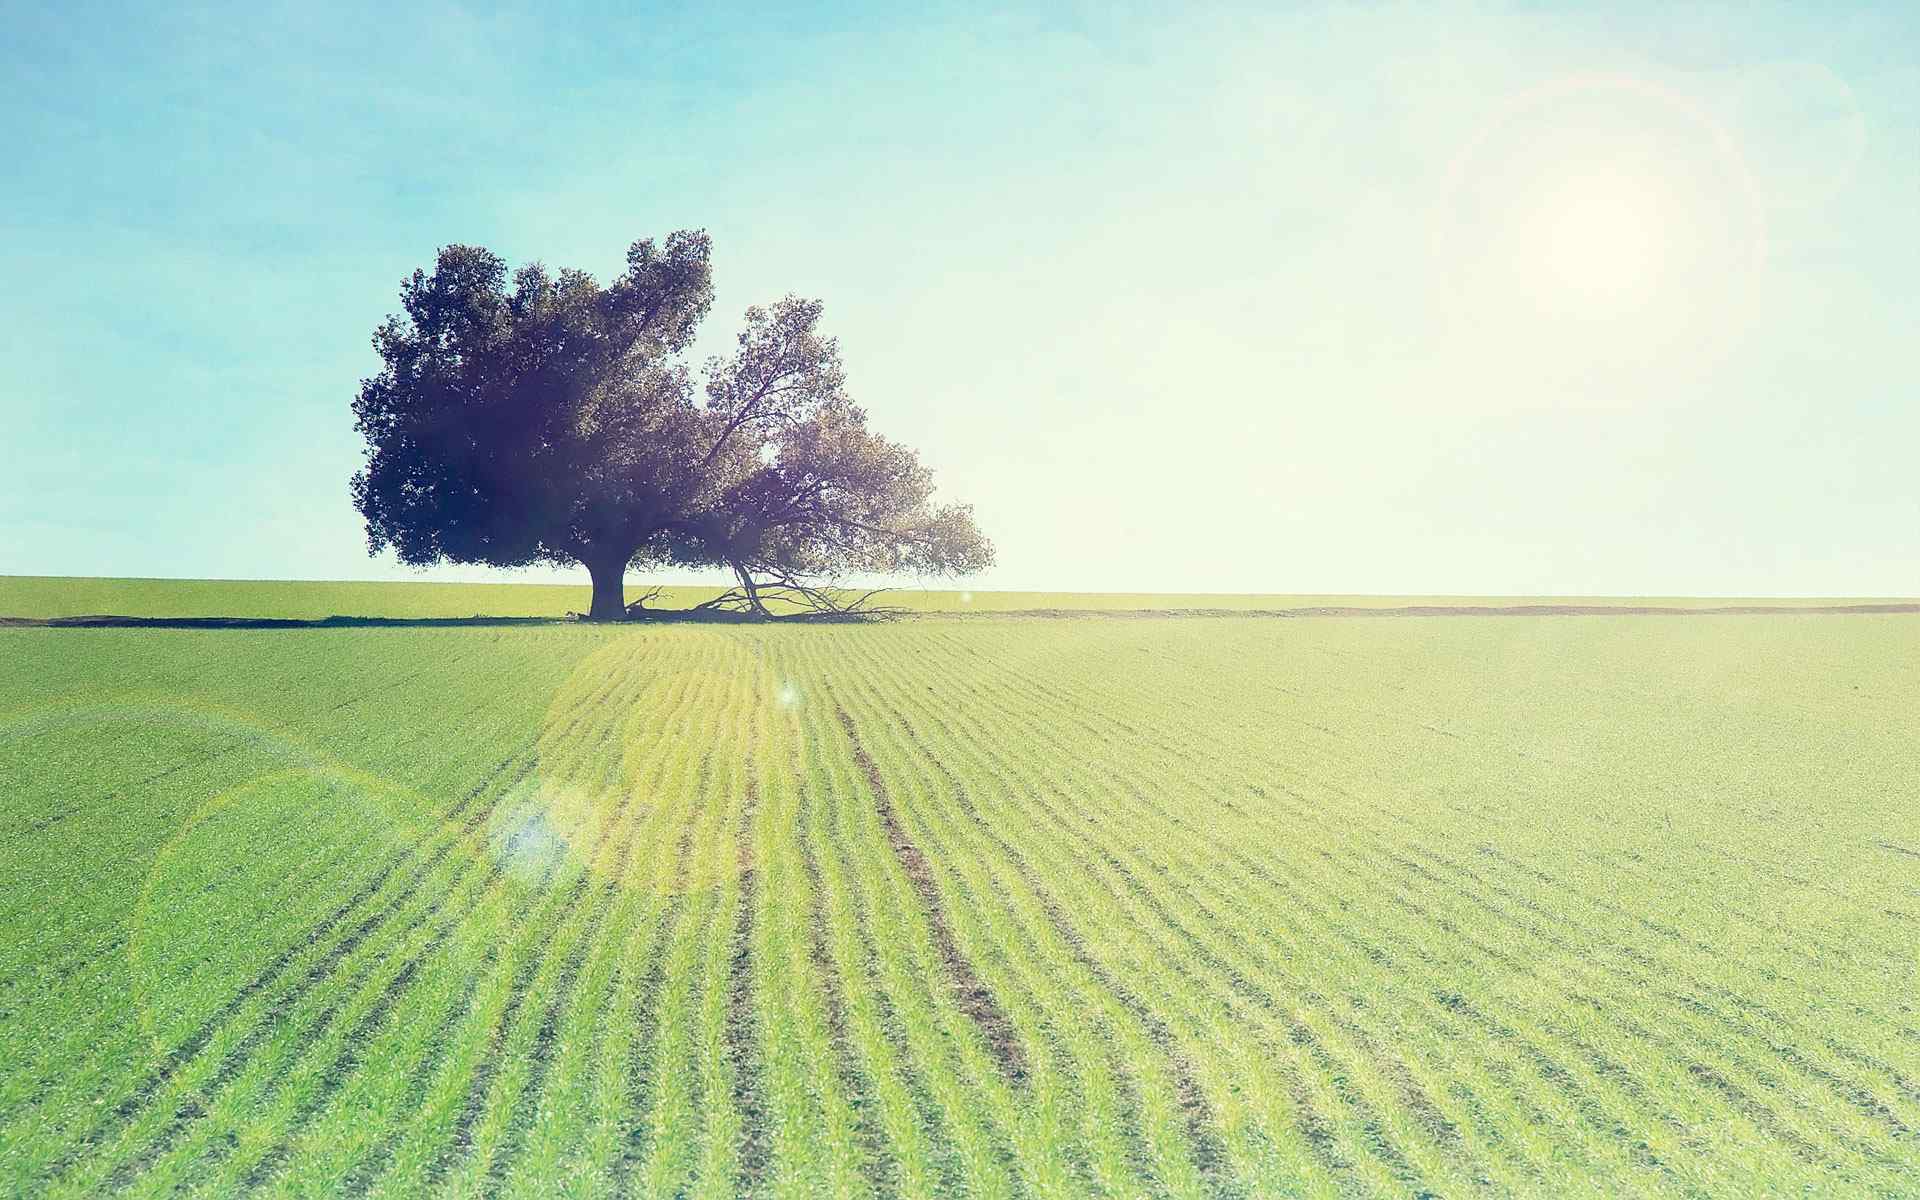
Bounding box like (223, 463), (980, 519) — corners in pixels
(0, 580), (1920, 1198)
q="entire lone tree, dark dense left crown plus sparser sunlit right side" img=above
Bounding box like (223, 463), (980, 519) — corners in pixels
(353, 232), (993, 618)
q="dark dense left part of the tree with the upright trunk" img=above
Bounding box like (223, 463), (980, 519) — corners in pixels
(351, 232), (712, 616)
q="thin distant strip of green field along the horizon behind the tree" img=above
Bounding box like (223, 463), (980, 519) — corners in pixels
(0, 576), (1904, 620)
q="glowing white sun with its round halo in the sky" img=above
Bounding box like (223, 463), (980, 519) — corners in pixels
(1434, 77), (1764, 403)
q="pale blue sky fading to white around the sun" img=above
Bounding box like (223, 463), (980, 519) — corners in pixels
(0, 4), (1920, 595)
